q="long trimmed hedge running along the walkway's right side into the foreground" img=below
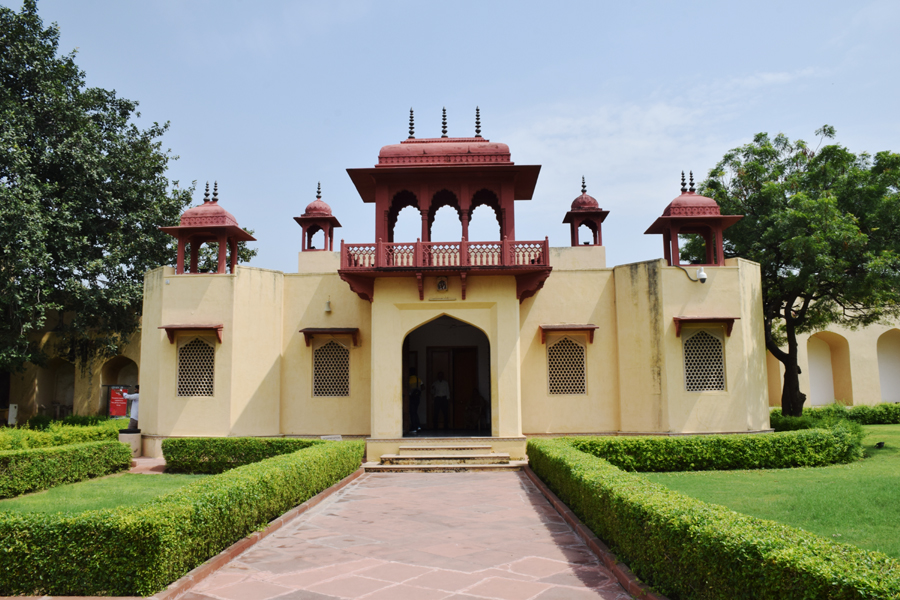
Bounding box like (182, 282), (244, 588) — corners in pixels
(528, 438), (900, 600)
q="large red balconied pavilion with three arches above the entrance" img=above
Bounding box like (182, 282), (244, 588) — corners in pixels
(340, 107), (551, 301)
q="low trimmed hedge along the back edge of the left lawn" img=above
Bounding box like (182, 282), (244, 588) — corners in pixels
(0, 441), (131, 498)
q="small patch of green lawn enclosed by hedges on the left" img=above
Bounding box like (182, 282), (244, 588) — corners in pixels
(0, 473), (207, 513)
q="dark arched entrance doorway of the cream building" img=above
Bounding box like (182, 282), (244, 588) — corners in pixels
(403, 315), (491, 437)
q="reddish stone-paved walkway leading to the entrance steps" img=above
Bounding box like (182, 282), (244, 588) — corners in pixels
(180, 472), (631, 600)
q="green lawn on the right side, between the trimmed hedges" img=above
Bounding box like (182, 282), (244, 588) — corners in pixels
(644, 425), (900, 558)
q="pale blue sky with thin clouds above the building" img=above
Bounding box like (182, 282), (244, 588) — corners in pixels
(7, 0), (900, 272)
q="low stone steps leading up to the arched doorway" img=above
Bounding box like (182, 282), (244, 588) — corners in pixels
(363, 440), (528, 473)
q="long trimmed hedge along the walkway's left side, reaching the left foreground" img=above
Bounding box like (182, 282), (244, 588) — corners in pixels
(0, 441), (365, 596)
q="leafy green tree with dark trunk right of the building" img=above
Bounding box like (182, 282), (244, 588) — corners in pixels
(685, 125), (900, 416)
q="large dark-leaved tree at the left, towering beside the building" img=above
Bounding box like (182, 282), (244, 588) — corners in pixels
(0, 0), (192, 370)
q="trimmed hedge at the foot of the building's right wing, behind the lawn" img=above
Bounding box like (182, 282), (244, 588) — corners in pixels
(568, 423), (863, 472)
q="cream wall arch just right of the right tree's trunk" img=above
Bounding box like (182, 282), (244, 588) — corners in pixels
(806, 331), (853, 406)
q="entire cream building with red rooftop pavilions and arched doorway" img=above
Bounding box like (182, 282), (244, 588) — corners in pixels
(141, 106), (768, 460)
